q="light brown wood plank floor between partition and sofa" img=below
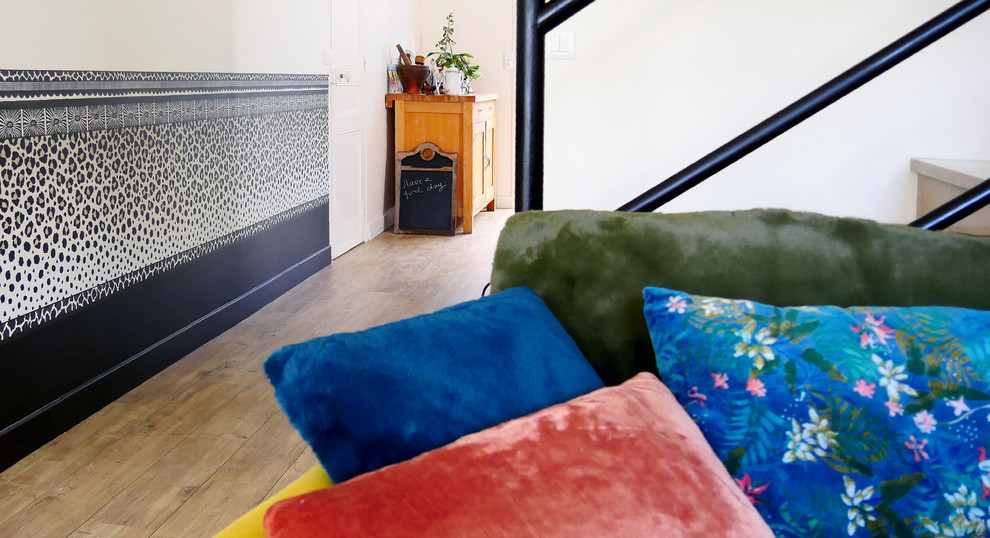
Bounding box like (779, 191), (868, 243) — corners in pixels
(0, 211), (511, 538)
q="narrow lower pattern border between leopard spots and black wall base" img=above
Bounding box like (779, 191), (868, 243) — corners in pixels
(0, 195), (330, 342)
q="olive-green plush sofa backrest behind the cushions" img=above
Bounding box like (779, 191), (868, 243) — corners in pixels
(492, 210), (990, 384)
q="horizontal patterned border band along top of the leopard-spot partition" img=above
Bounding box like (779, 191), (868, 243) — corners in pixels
(0, 70), (330, 139)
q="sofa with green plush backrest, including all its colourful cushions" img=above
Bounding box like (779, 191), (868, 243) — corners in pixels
(221, 210), (990, 536)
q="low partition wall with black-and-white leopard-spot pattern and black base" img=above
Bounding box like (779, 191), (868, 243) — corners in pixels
(0, 71), (330, 464)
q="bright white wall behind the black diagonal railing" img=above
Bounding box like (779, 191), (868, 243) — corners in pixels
(545, 0), (990, 222)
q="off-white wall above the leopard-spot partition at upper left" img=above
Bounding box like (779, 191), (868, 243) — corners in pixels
(0, 0), (330, 73)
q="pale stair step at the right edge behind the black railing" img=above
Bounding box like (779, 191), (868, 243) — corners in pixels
(911, 159), (990, 235)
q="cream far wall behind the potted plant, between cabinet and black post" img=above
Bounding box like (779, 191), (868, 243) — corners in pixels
(421, 0), (516, 208)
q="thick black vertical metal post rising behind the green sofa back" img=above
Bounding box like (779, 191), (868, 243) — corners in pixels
(516, 0), (545, 211)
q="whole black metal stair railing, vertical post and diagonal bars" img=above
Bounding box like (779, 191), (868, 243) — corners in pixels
(516, 0), (990, 229)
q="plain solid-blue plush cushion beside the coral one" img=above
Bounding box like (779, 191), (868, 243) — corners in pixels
(265, 288), (603, 482)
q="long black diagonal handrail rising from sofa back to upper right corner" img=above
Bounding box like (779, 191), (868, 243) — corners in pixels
(619, 0), (990, 212)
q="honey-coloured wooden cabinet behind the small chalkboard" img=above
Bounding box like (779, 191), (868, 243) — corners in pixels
(385, 94), (498, 233)
